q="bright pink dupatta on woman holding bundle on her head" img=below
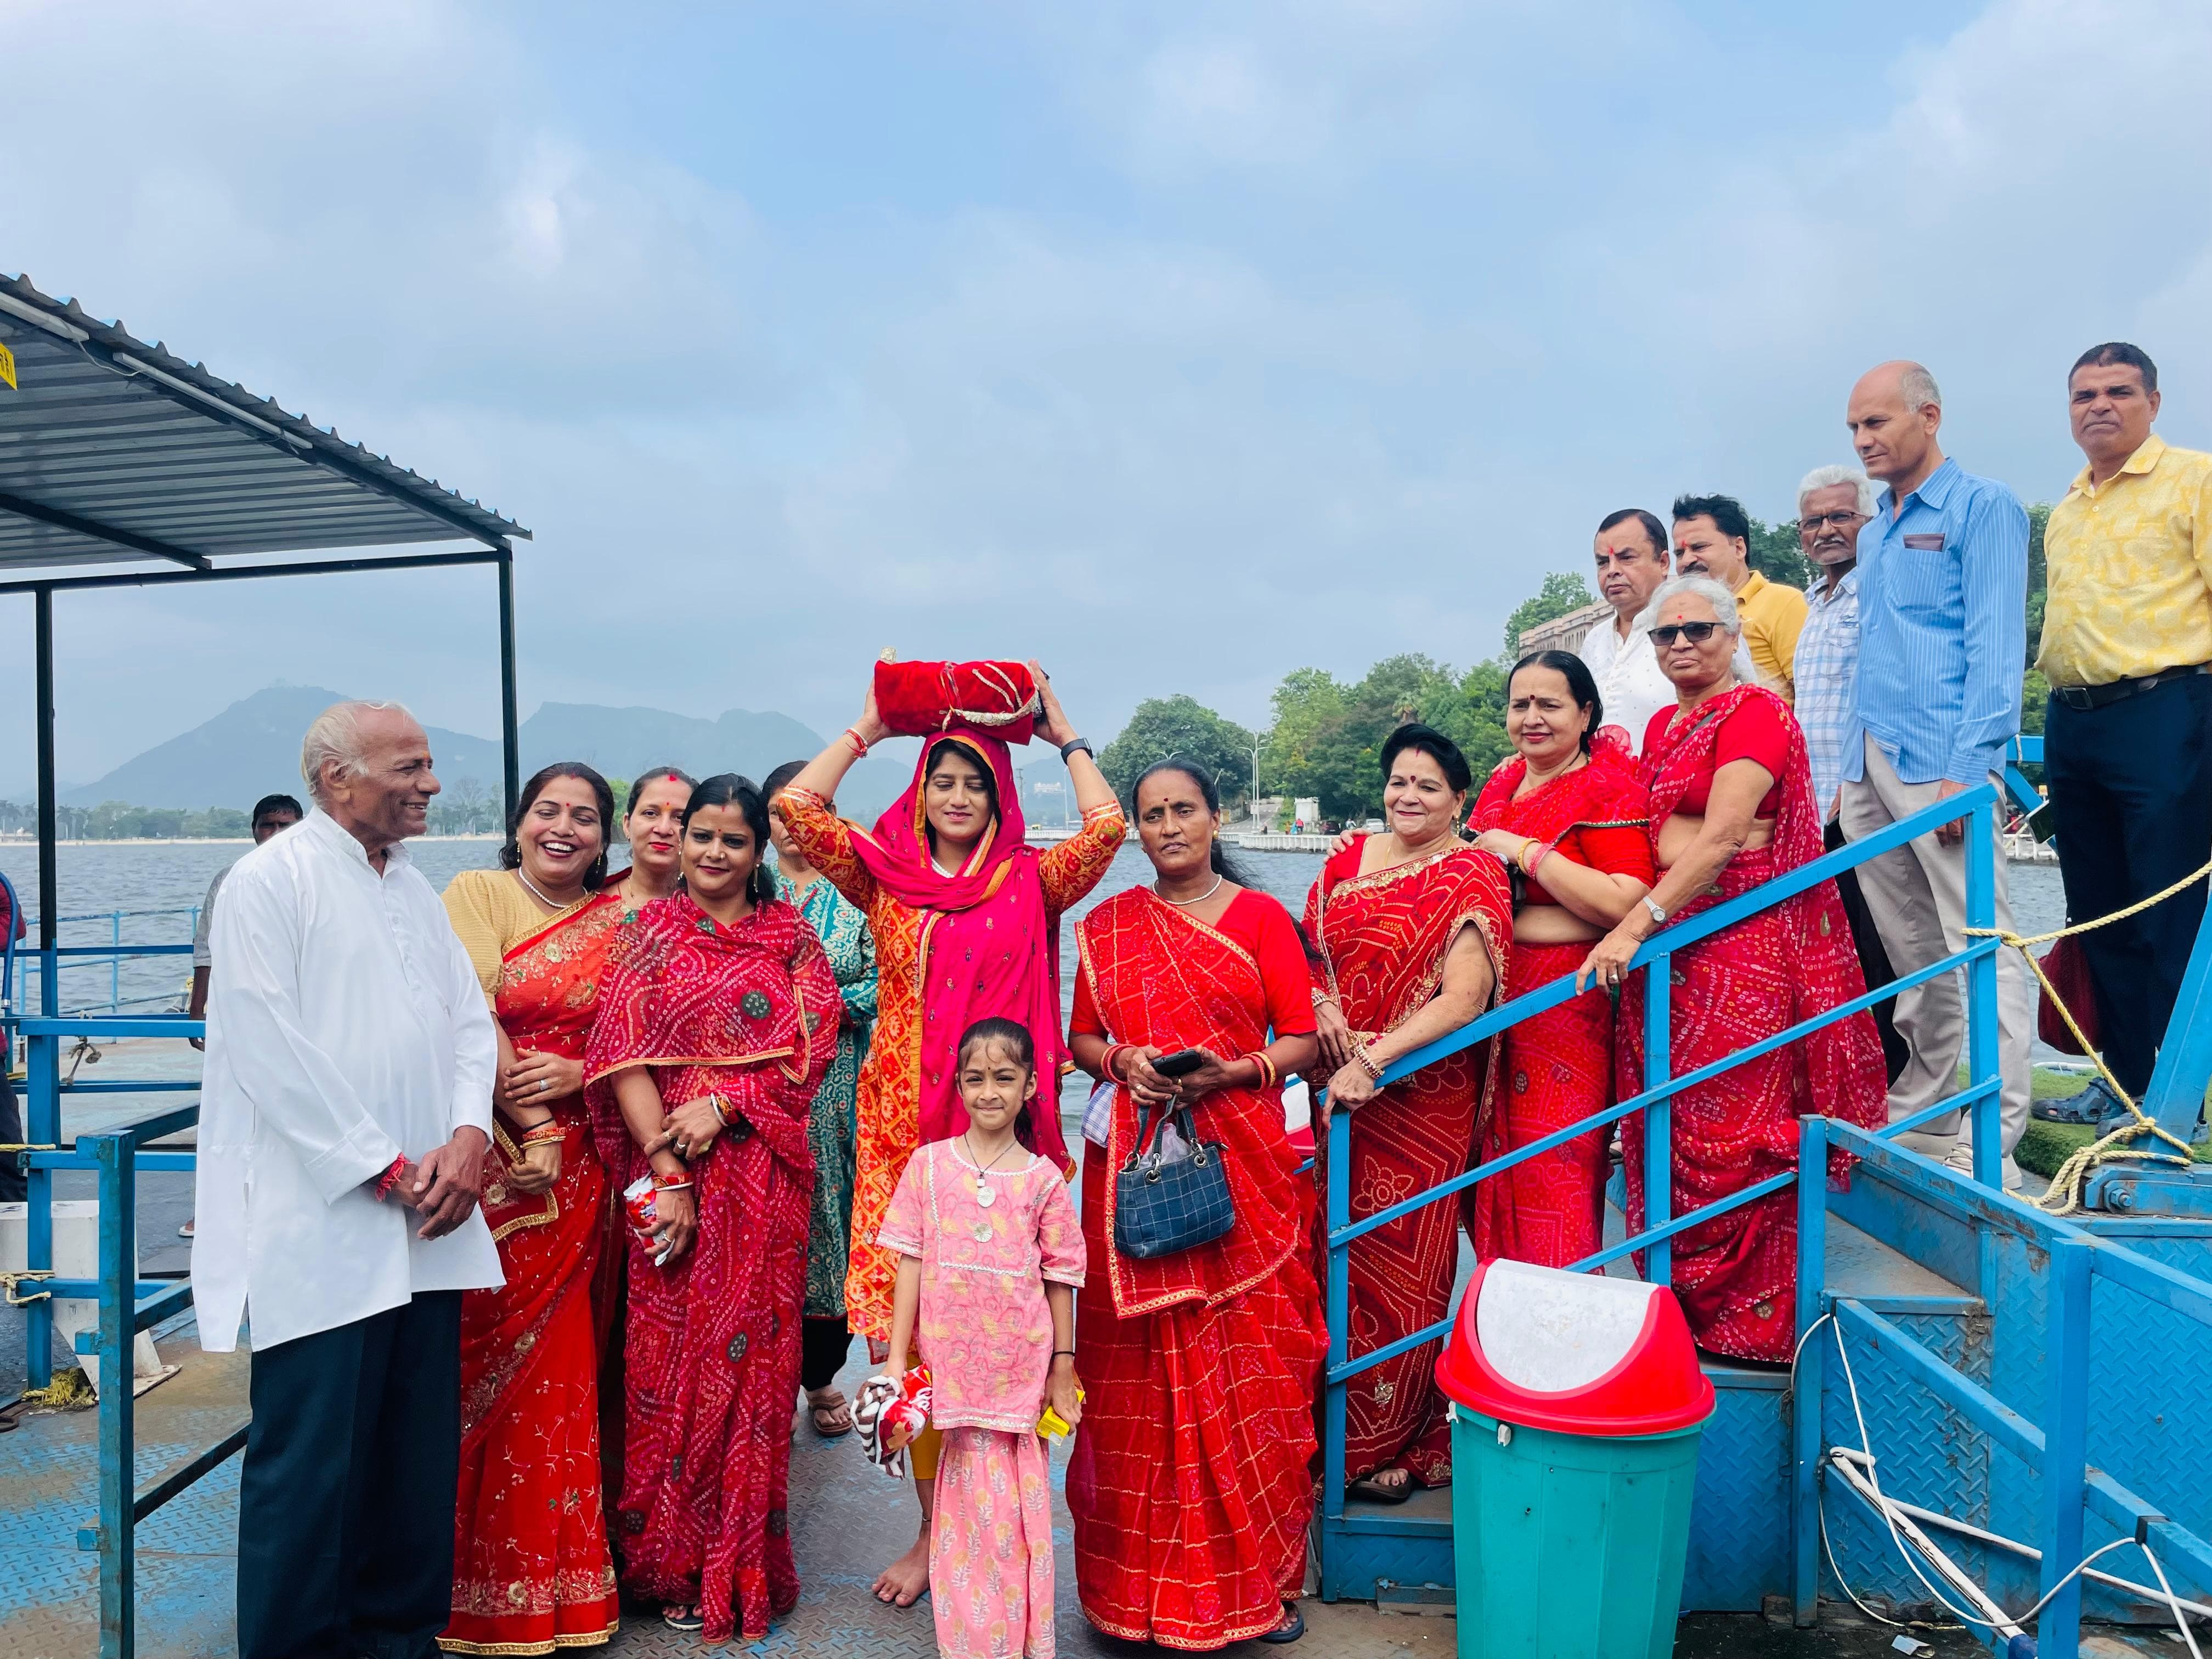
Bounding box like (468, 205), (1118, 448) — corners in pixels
(851, 725), (1073, 1172)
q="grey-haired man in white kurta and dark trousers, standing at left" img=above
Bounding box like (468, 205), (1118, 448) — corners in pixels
(193, 703), (500, 1659)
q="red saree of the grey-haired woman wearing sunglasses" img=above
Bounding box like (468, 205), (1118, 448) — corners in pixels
(1617, 686), (1887, 1363)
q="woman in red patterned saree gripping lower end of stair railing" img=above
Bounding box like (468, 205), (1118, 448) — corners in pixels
(1305, 725), (1513, 1504)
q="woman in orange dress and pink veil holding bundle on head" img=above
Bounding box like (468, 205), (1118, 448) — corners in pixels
(776, 664), (1126, 1606)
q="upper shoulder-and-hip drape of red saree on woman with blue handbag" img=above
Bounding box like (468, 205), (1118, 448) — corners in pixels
(1075, 887), (1305, 1318)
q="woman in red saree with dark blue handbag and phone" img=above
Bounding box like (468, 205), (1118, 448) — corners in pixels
(1068, 761), (1327, 1650)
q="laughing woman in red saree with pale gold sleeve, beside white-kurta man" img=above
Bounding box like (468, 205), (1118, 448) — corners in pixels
(438, 763), (622, 1655)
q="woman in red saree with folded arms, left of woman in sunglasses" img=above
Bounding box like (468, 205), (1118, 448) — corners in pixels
(1466, 650), (1652, 1267)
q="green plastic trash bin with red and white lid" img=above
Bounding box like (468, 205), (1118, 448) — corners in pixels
(1436, 1261), (1714, 1659)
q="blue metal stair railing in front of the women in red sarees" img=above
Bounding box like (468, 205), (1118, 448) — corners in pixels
(1318, 783), (2004, 1599)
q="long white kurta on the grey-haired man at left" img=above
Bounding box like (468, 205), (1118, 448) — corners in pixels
(193, 810), (500, 1354)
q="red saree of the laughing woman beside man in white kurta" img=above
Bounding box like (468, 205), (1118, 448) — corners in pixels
(438, 894), (622, 1655)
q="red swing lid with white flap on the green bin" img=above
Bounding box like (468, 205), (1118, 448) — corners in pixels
(1436, 1259), (1714, 1436)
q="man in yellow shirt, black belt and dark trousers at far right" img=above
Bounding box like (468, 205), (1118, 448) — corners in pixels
(2035, 341), (2212, 1132)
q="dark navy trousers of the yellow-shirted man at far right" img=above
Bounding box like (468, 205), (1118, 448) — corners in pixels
(2044, 675), (2212, 1099)
